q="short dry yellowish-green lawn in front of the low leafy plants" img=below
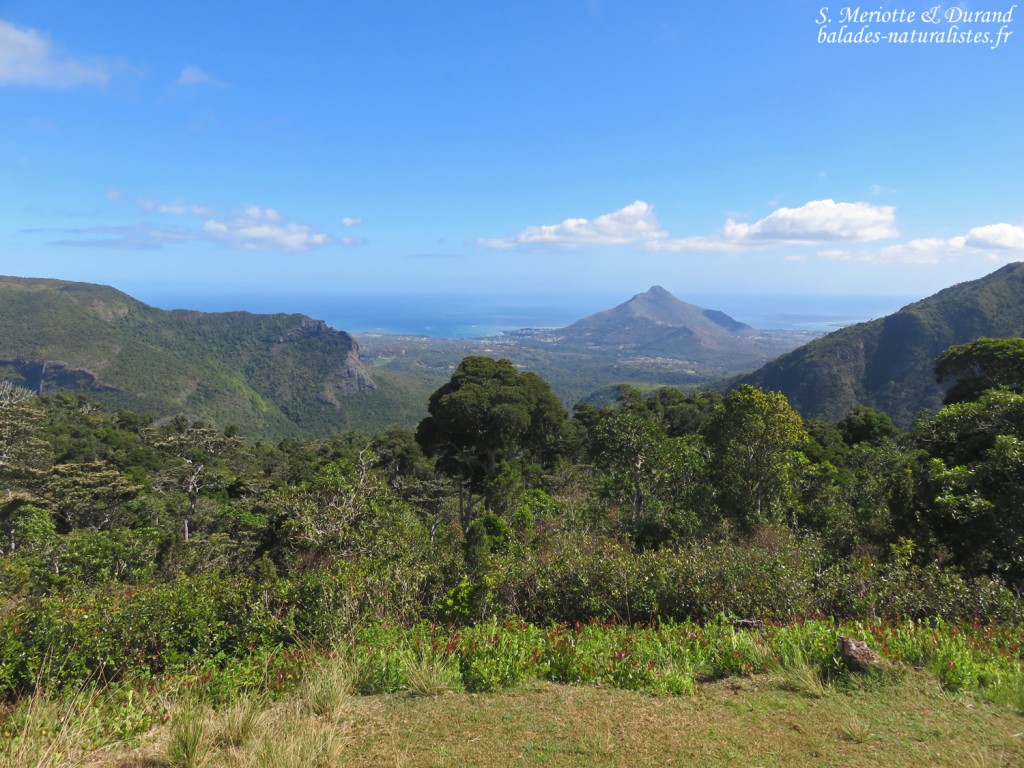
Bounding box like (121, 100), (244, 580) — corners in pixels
(81, 672), (1024, 768)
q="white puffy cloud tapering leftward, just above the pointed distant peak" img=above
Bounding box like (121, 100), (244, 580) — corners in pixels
(477, 200), (667, 249)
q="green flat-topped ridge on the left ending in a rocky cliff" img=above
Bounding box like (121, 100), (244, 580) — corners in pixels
(0, 278), (428, 437)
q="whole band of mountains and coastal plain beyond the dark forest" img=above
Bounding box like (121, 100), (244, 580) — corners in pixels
(19, 263), (1024, 438)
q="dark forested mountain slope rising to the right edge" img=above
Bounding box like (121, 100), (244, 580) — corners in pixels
(732, 262), (1024, 427)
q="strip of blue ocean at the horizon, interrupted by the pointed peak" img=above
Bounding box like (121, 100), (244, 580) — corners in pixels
(134, 290), (913, 339)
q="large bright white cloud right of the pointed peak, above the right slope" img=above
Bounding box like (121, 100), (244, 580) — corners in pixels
(722, 200), (898, 243)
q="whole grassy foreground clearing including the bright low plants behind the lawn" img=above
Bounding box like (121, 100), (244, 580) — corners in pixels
(0, 621), (1024, 768)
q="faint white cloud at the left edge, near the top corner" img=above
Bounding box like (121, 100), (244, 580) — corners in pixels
(0, 19), (111, 88)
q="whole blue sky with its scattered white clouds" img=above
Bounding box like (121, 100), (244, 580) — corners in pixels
(0, 0), (1024, 309)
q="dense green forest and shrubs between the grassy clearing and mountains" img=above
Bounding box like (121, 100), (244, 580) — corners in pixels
(0, 342), (1024, 694)
